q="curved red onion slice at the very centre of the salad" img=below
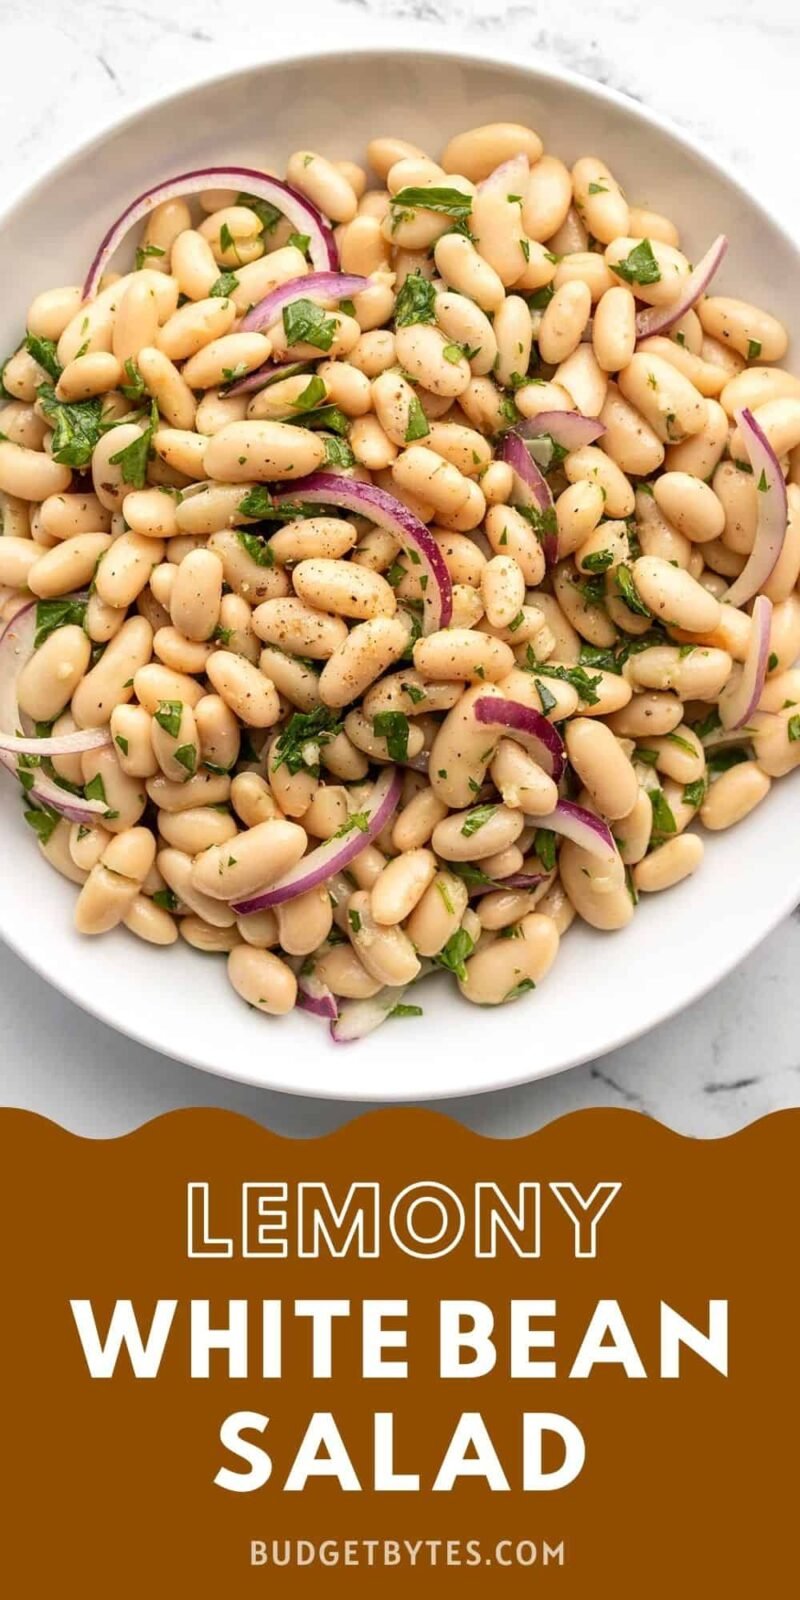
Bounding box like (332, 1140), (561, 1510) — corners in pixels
(272, 470), (454, 634)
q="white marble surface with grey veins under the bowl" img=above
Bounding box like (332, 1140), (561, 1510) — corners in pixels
(0, 0), (800, 1136)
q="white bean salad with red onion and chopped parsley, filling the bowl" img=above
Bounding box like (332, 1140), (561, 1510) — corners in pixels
(0, 123), (800, 1040)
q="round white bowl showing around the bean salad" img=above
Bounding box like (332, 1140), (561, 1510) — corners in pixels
(0, 50), (800, 1101)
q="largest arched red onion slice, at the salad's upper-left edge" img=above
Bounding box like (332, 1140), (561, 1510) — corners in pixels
(83, 166), (339, 301)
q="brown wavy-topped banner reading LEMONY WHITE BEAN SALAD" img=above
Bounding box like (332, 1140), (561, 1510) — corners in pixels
(0, 1110), (800, 1600)
